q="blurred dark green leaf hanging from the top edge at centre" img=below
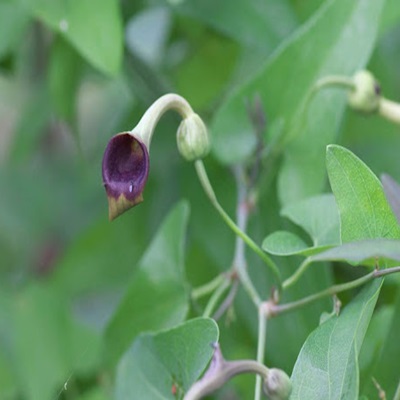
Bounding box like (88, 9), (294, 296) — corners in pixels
(171, 0), (297, 50)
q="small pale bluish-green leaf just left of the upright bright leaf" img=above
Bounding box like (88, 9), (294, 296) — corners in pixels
(281, 194), (340, 247)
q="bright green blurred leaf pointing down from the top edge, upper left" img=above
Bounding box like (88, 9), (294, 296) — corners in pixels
(23, 0), (123, 75)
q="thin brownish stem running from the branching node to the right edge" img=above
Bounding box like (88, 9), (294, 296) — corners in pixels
(269, 267), (400, 315)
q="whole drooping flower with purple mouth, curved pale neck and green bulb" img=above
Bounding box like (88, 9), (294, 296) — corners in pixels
(102, 94), (210, 220)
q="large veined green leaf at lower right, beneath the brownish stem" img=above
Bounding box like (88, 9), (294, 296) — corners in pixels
(290, 280), (382, 400)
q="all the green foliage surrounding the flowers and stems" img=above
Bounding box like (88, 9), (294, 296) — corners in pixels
(0, 0), (400, 400)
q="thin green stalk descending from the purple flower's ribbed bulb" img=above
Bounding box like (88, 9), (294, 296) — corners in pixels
(195, 160), (281, 286)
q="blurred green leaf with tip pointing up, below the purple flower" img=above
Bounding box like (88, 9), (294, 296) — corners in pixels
(105, 202), (189, 363)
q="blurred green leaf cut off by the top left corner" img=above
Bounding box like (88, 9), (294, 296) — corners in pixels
(0, 0), (29, 59)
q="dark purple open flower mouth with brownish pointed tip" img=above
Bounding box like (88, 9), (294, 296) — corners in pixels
(102, 132), (150, 220)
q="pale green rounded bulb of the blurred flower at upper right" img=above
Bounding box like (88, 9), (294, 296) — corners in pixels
(348, 71), (381, 113)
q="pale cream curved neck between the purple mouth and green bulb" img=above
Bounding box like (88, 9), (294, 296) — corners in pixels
(132, 93), (194, 149)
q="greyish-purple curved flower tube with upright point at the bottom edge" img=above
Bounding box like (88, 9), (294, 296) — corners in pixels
(184, 344), (269, 400)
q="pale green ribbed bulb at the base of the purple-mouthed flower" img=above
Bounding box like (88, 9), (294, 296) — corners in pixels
(177, 113), (210, 161)
